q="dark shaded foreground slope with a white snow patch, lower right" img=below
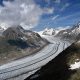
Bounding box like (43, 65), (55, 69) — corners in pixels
(25, 41), (80, 80)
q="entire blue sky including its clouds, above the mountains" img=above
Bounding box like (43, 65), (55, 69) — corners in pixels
(0, 0), (80, 30)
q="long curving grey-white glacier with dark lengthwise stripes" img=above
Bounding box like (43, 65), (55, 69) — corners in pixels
(0, 36), (70, 80)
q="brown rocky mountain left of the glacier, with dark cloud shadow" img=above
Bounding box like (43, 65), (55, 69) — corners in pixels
(0, 25), (48, 64)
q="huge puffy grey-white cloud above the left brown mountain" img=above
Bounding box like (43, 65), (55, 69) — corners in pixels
(0, 0), (43, 29)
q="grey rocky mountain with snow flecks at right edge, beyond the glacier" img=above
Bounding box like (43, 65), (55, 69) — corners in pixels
(56, 23), (80, 40)
